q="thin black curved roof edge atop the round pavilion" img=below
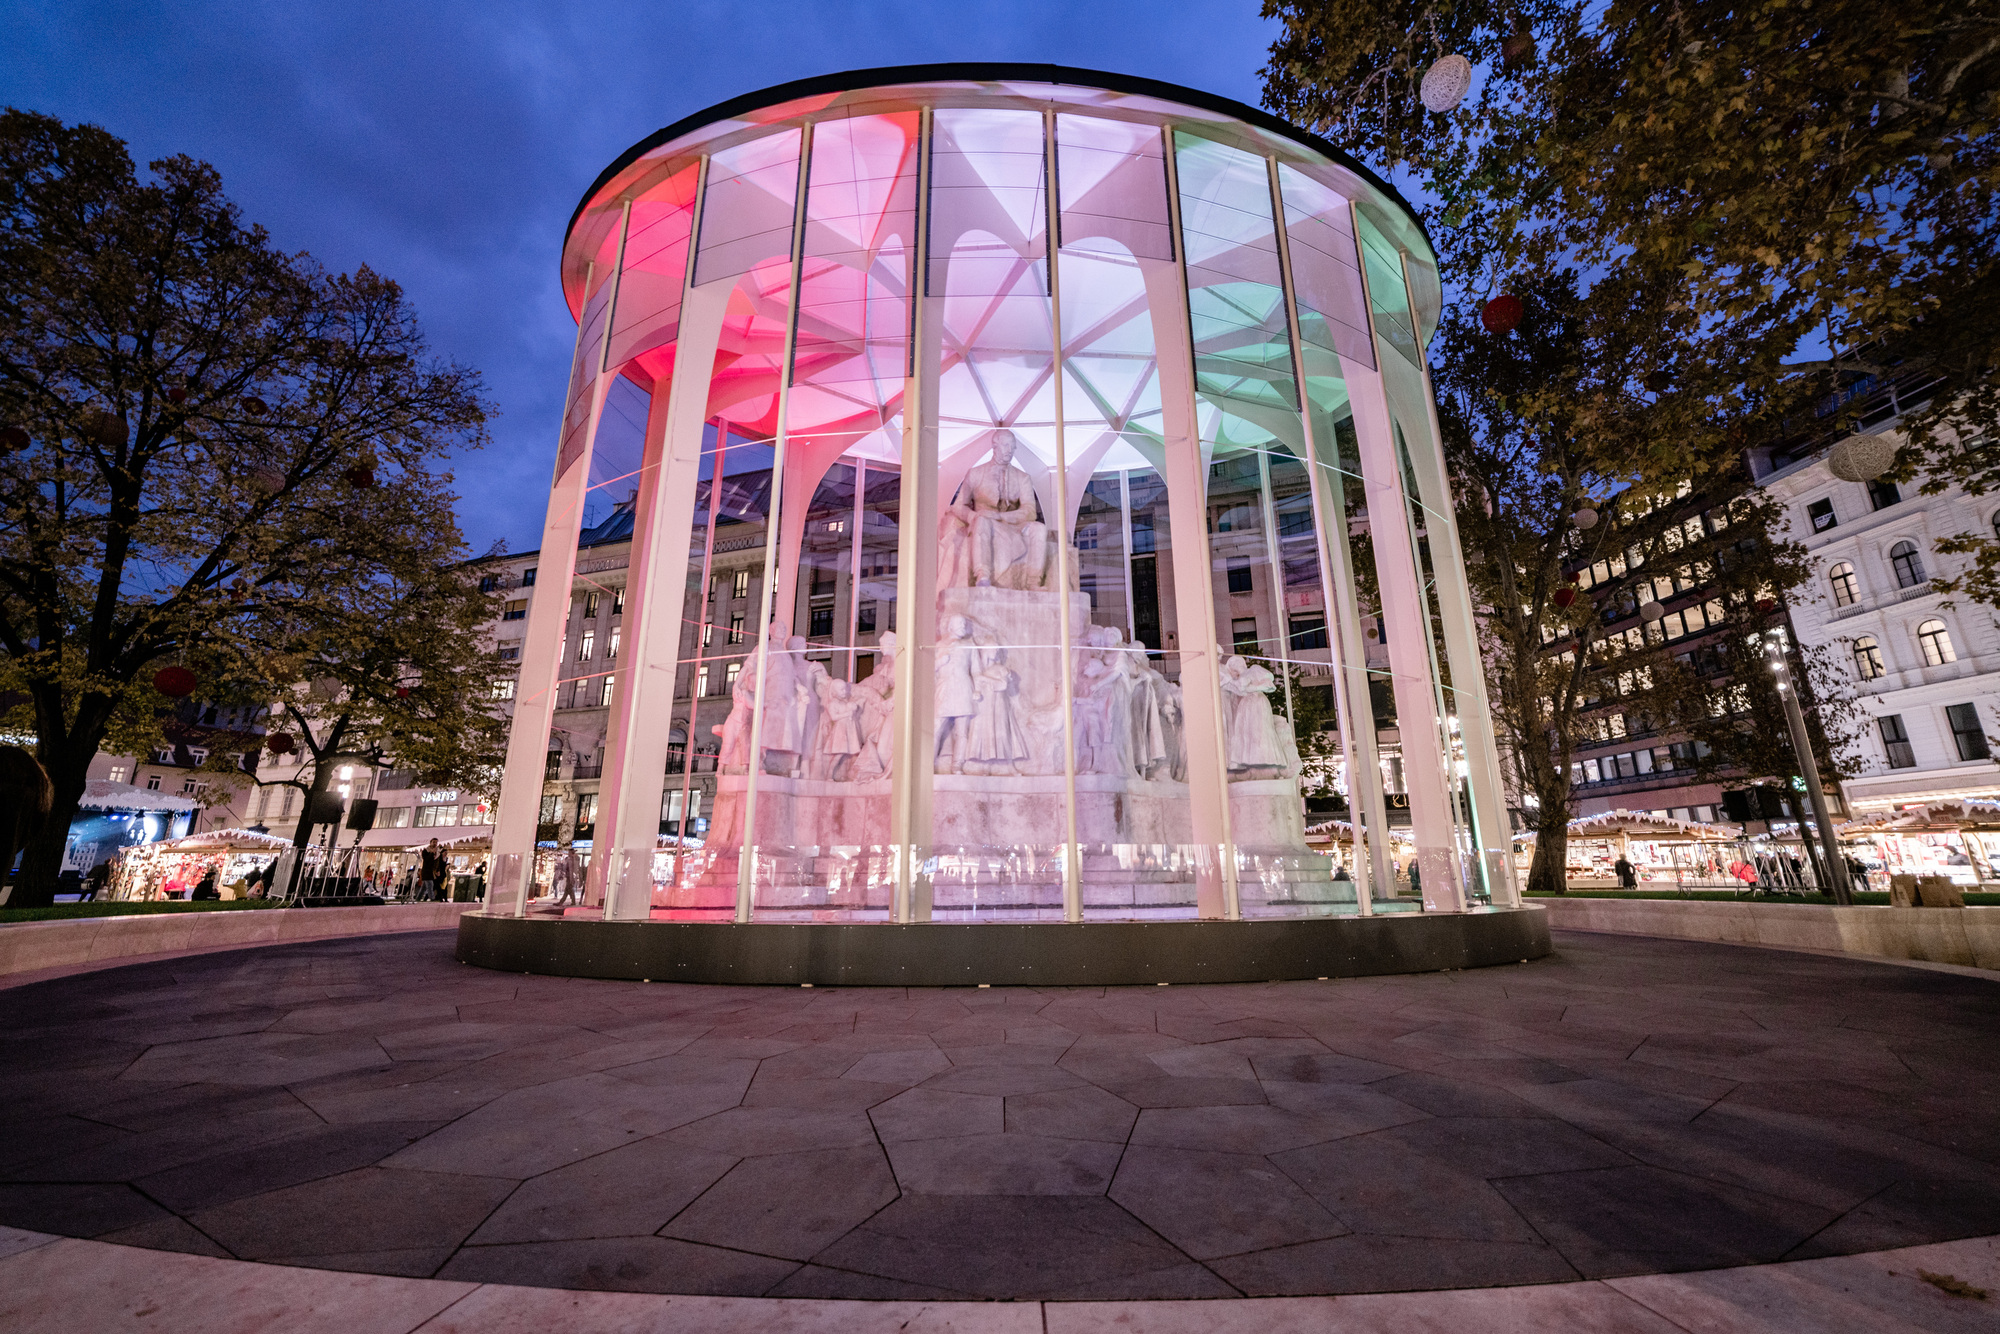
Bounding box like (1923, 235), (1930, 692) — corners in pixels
(562, 60), (1438, 264)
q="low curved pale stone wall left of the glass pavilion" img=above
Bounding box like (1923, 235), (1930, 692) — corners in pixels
(0, 904), (478, 986)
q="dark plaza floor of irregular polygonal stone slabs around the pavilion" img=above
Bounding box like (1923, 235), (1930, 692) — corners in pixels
(0, 932), (2000, 1300)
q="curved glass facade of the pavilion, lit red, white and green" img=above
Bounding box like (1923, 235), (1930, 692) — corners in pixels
(494, 80), (1514, 922)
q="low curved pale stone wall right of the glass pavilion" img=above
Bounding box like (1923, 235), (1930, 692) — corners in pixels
(1530, 898), (2000, 970)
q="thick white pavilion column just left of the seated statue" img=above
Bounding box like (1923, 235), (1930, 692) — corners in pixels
(888, 106), (944, 922)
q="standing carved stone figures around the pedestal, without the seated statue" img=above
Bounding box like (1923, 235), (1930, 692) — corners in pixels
(714, 614), (1298, 782)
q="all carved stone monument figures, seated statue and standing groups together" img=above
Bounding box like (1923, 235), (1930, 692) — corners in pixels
(714, 430), (1298, 782)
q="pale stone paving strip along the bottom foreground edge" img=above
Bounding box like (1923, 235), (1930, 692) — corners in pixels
(0, 1228), (2000, 1334)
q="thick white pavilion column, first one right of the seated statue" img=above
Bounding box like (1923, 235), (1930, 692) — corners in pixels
(1140, 126), (1242, 922)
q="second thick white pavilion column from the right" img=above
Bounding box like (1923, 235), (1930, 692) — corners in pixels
(1342, 206), (1466, 912)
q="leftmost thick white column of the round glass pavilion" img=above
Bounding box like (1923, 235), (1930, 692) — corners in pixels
(494, 243), (630, 916)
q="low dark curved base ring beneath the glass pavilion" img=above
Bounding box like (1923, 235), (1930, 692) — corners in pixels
(458, 908), (1552, 986)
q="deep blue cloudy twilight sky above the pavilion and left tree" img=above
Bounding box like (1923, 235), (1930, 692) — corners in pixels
(0, 0), (1400, 550)
